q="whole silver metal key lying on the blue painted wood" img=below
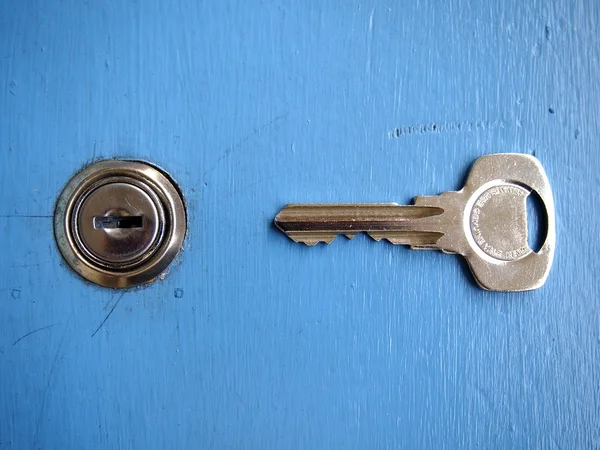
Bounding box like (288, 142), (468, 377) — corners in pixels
(275, 153), (556, 292)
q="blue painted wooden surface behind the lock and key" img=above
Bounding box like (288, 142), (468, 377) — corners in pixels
(0, 0), (600, 449)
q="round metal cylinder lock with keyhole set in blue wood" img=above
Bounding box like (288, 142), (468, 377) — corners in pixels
(54, 160), (187, 288)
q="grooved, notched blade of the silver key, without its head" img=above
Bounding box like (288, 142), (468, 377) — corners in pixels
(275, 203), (444, 248)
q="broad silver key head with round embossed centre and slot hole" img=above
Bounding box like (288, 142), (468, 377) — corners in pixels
(415, 153), (556, 291)
